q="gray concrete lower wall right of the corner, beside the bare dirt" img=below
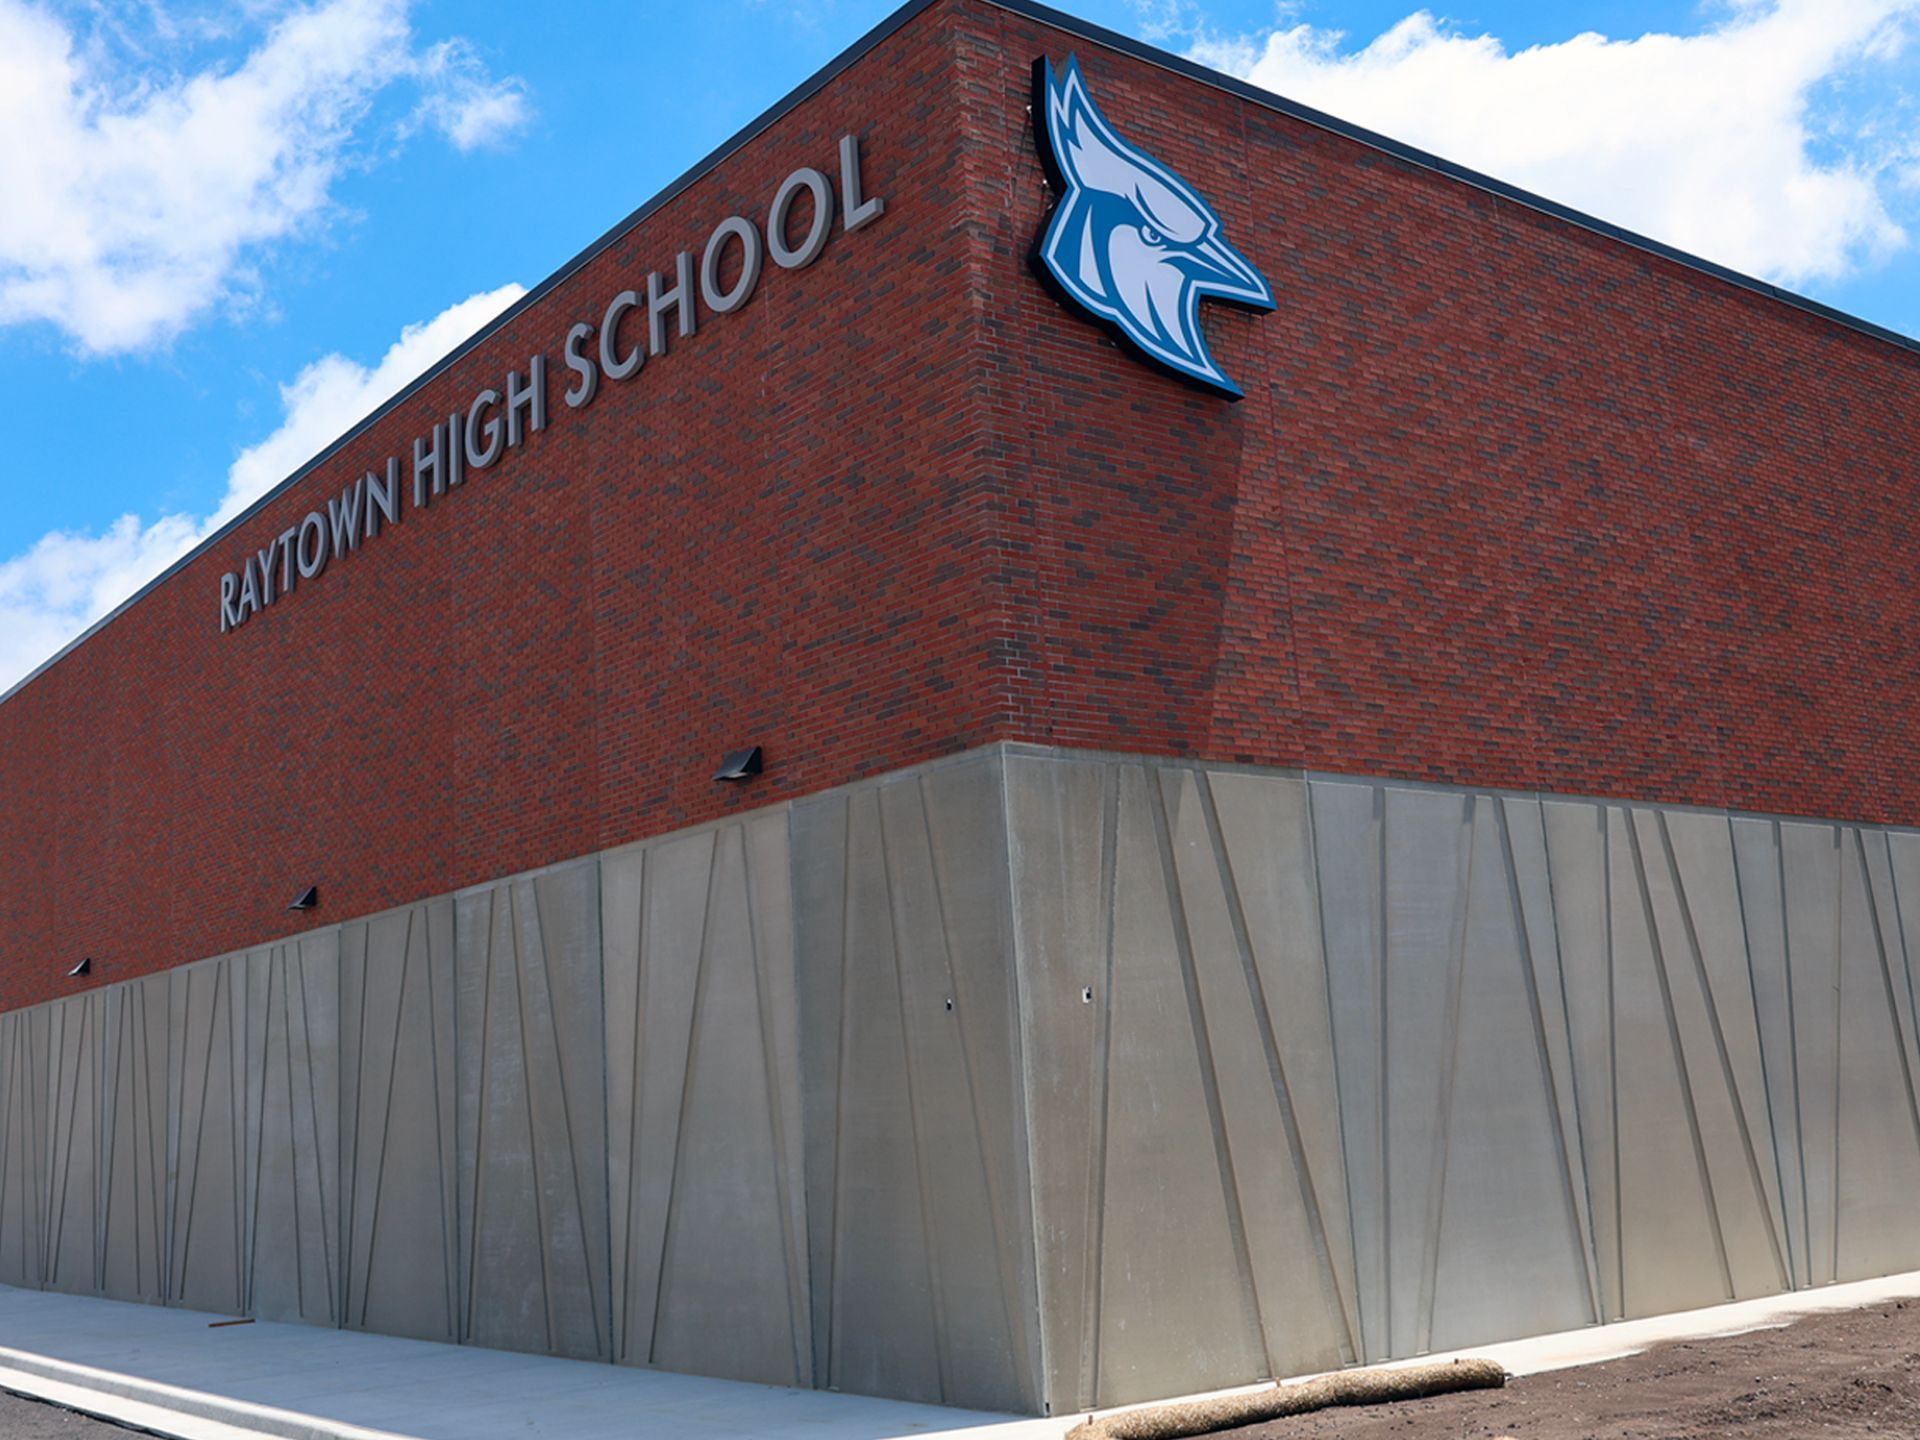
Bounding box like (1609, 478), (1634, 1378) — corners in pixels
(1008, 753), (1920, 1409)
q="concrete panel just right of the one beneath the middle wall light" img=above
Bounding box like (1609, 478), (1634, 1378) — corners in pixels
(340, 899), (459, 1340)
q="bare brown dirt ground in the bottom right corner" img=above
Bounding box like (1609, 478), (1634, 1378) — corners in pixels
(1229, 1300), (1920, 1440)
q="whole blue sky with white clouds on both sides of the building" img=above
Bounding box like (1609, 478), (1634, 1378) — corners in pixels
(0, 0), (1920, 687)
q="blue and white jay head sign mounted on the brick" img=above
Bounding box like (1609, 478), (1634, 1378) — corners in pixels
(1033, 56), (1273, 399)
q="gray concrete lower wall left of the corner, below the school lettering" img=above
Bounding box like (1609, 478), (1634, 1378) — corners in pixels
(0, 753), (1041, 1409)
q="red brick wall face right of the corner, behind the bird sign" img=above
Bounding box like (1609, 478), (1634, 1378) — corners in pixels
(970, 10), (1920, 824)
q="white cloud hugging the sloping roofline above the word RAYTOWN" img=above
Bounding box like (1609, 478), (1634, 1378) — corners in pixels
(0, 284), (526, 691)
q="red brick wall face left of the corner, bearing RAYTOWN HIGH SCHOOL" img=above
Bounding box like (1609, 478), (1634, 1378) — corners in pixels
(0, 2), (1006, 1006)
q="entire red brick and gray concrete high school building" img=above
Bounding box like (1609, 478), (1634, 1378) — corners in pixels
(0, 0), (1920, 1411)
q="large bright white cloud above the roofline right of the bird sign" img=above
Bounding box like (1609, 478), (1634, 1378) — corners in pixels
(1192, 0), (1920, 284)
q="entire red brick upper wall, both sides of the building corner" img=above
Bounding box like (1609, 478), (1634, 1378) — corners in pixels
(0, 0), (1920, 1006)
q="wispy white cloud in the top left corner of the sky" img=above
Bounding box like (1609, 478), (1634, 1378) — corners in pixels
(0, 0), (526, 353)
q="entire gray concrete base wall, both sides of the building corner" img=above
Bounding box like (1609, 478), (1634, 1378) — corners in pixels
(0, 747), (1920, 1411)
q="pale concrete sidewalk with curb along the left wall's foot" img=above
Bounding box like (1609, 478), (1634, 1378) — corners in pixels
(0, 1286), (1071, 1440)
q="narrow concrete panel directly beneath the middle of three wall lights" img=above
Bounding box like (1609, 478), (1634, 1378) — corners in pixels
(246, 929), (342, 1325)
